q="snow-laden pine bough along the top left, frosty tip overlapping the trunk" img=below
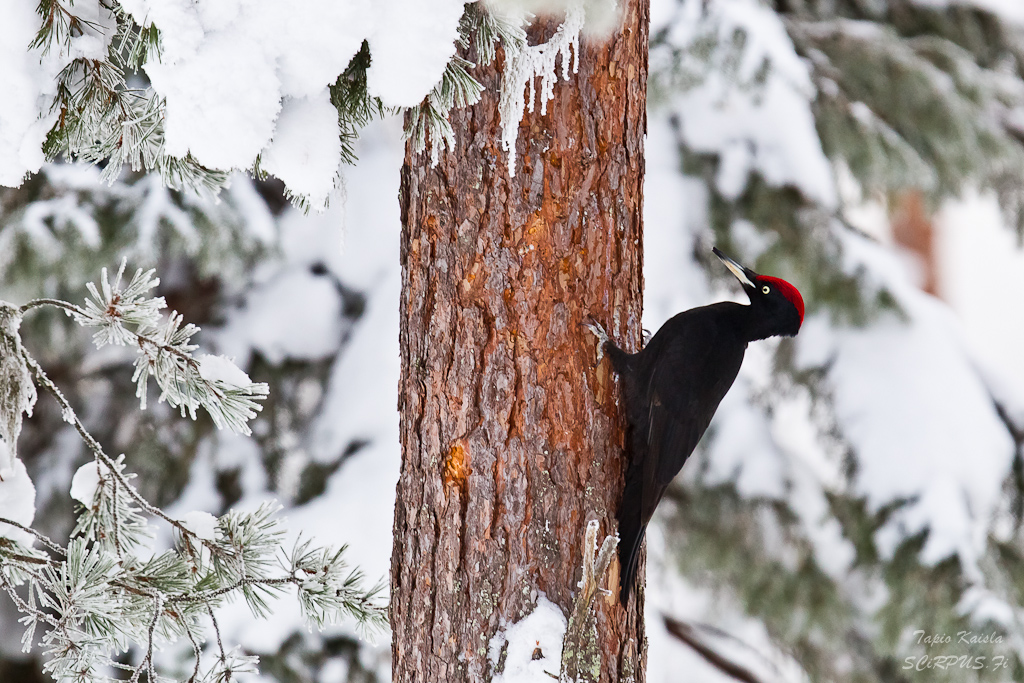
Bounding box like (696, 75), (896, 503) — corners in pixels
(0, 0), (615, 210)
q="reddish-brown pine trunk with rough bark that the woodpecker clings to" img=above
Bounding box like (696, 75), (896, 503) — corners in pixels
(391, 0), (648, 683)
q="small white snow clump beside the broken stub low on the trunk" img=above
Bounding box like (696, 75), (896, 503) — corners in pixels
(487, 593), (566, 683)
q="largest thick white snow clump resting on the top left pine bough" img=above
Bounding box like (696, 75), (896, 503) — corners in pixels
(126, 0), (464, 196)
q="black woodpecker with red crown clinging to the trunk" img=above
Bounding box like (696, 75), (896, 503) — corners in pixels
(587, 248), (804, 604)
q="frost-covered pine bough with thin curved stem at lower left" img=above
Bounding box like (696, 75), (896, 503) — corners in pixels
(0, 263), (384, 682)
